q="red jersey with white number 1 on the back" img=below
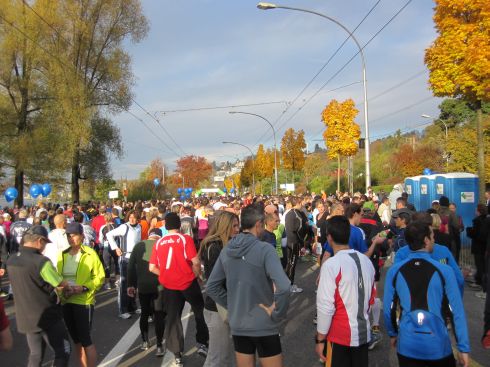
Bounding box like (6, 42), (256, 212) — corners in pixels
(150, 233), (197, 291)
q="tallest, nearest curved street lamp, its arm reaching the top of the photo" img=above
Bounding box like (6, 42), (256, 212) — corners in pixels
(257, 2), (371, 191)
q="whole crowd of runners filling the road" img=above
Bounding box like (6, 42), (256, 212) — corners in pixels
(0, 190), (490, 367)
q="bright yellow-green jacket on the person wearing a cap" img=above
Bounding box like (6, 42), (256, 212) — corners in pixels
(57, 245), (105, 305)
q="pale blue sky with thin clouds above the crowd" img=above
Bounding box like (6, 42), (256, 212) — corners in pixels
(112, 0), (440, 179)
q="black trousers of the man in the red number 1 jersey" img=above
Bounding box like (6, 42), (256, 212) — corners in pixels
(163, 279), (209, 354)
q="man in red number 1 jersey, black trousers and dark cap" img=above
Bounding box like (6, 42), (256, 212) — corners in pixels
(149, 213), (209, 366)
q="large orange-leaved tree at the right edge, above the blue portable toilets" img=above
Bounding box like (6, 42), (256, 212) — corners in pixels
(425, 0), (490, 200)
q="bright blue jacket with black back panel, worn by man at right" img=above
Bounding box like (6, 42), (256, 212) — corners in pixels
(383, 252), (470, 360)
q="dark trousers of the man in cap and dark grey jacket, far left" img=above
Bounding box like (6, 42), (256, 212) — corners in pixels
(26, 318), (71, 367)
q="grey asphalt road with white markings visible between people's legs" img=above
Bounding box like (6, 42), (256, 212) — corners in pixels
(0, 261), (490, 367)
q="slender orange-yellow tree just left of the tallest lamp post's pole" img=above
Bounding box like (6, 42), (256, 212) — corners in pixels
(322, 99), (361, 191)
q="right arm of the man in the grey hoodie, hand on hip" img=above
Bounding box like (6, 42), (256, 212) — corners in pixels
(264, 246), (291, 321)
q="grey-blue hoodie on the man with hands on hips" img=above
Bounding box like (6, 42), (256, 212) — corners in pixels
(207, 233), (291, 336)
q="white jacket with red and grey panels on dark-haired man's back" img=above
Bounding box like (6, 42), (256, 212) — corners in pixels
(316, 249), (376, 347)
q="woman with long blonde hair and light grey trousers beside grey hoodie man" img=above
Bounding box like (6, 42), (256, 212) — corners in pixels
(199, 211), (240, 367)
